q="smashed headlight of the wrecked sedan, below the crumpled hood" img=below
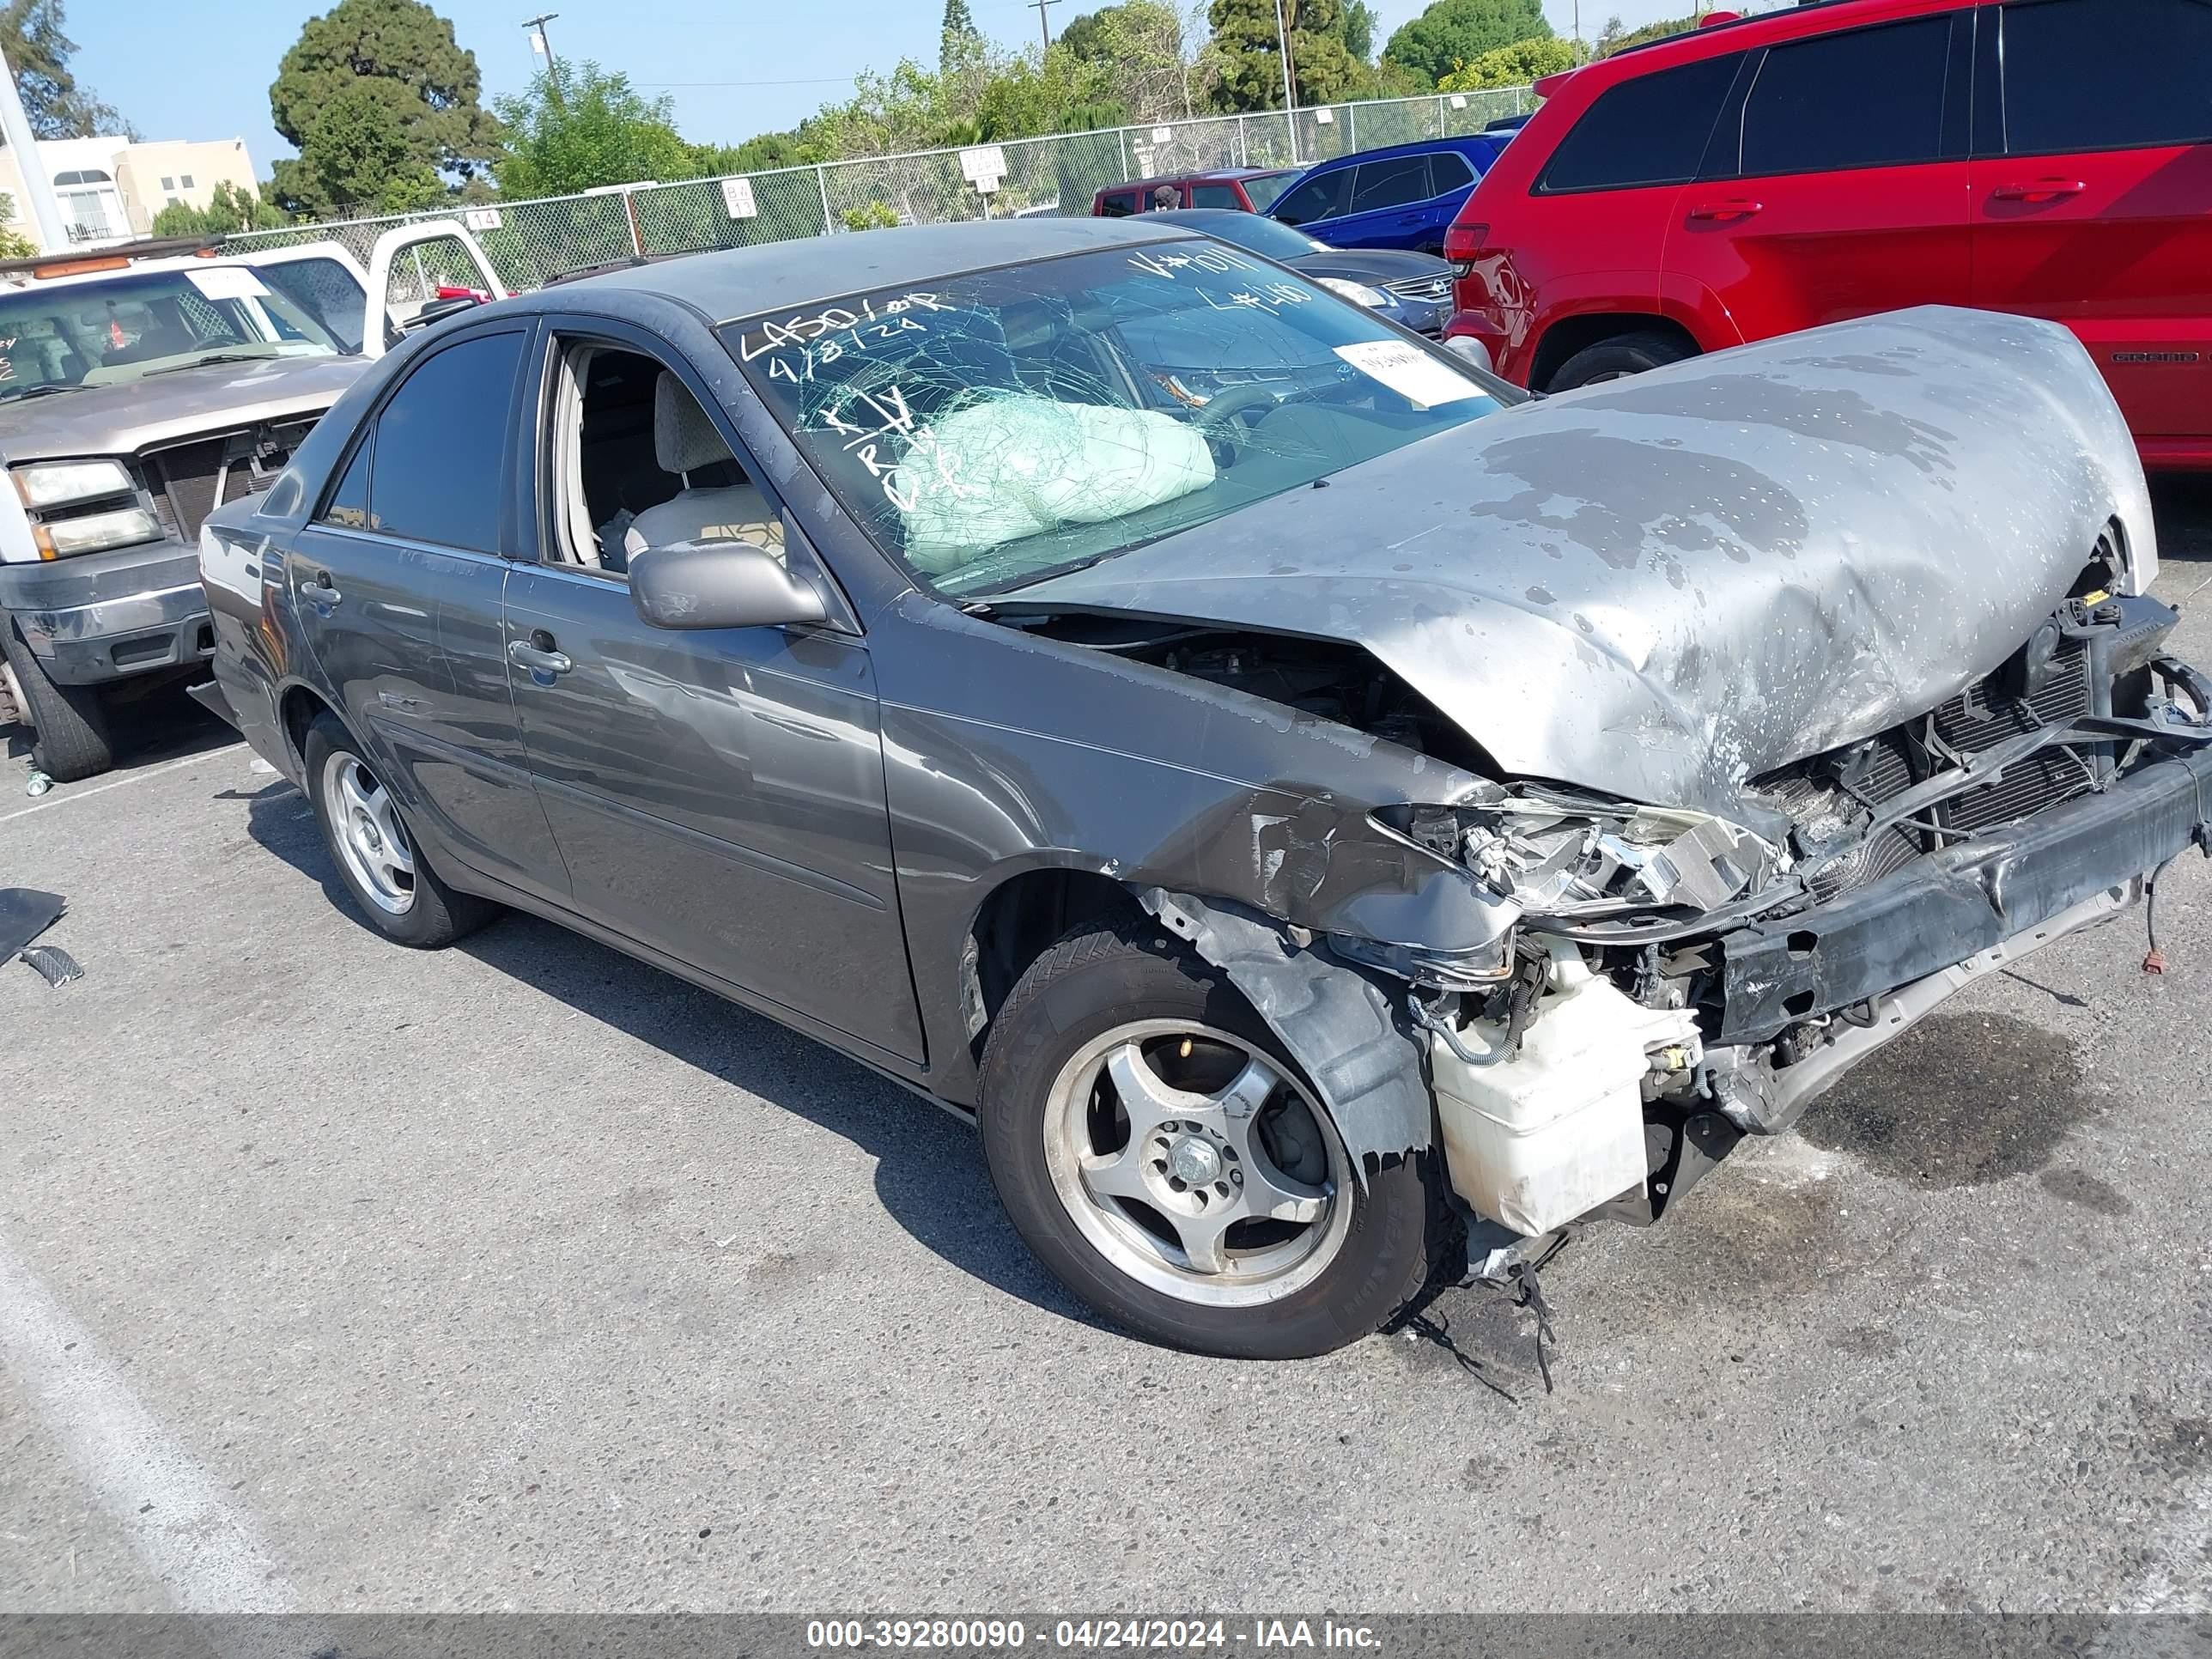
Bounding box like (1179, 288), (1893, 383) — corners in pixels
(1376, 794), (1790, 921)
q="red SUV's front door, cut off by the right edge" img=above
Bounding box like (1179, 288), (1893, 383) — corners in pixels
(1973, 0), (2212, 460)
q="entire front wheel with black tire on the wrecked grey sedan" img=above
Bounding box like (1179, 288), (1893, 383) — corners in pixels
(980, 922), (1431, 1358)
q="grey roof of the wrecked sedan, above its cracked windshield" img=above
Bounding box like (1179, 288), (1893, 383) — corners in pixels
(557, 215), (1197, 321)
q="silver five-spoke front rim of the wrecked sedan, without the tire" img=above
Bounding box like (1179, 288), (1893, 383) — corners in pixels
(1044, 1020), (1352, 1307)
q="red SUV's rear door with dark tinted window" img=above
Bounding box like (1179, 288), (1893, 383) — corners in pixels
(1662, 11), (1973, 351)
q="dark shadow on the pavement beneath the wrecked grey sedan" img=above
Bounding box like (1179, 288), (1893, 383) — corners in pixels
(246, 781), (1106, 1329)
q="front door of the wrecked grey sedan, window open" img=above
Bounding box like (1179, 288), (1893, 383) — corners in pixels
(507, 316), (925, 1060)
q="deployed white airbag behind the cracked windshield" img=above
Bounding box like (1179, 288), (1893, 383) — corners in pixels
(890, 398), (1214, 573)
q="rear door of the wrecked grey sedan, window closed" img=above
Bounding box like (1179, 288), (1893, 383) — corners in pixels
(283, 321), (568, 898)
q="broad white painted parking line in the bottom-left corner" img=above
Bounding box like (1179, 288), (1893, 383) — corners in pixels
(0, 1239), (296, 1613)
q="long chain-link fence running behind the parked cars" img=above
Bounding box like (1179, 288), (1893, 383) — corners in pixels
(226, 86), (1531, 303)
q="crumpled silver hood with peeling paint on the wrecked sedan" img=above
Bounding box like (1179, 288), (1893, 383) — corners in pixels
(1020, 307), (2157, 814)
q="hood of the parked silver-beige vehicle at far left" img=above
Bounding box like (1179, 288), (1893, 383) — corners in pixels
(0, 356), (369, 465)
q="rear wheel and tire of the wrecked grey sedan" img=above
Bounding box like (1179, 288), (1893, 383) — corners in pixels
(301, 714), (498, 951)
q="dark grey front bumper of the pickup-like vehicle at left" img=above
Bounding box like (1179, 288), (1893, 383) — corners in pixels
(0, 542), (215, 686)
